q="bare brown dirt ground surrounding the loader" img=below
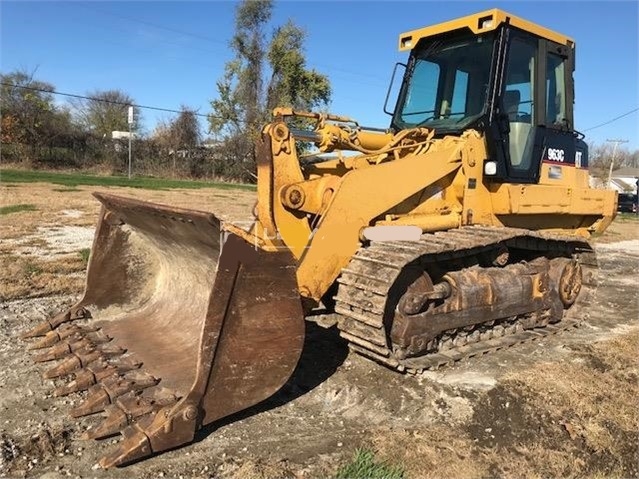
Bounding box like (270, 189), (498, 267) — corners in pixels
(0, 184), (639, 479)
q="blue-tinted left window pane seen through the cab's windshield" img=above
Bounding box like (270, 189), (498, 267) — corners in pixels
(402, 60), (440, 124)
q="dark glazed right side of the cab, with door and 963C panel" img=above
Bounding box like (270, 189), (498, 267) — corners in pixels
(501, 30), (587, 183)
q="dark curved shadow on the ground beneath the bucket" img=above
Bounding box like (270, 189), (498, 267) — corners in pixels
(193, 321), (348, 442)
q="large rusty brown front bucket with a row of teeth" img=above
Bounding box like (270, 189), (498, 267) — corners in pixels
(23, 193), (304, 467)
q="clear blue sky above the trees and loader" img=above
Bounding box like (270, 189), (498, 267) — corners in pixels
(0, 0), (639, 150)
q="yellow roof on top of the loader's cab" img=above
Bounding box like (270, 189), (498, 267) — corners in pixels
(399, 8), (575, 51)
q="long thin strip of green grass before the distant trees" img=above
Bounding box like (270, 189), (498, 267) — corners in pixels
(0, 169), (256, 191)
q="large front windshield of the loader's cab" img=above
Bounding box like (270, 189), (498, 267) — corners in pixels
(393, 35), (493, 130)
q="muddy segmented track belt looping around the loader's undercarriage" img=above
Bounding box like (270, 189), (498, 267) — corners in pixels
(335, 226), (597, 373)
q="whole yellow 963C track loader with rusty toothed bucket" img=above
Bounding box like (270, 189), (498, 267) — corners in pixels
(24, 9), (617, 468)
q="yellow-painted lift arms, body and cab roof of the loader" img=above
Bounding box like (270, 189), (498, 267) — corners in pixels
(237, 9), (616, 303)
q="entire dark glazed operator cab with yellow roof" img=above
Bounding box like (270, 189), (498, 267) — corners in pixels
(391, 9), (588, 183)
